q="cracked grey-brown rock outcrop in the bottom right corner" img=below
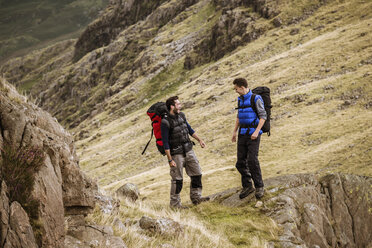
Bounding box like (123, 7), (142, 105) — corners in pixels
(213, 174), (372, 248)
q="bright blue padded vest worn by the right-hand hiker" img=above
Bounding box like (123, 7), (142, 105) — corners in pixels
(238, 91), (263, 135)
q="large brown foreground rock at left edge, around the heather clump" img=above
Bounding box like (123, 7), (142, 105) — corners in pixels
(0, 79), (97, 247)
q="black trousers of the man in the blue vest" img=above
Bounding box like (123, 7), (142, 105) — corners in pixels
(235, 134), (264, 188)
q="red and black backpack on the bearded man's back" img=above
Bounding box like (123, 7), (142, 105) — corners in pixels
(142, 102), (168, 156)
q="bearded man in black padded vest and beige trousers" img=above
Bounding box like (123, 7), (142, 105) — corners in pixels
(161, 96), (209, 208)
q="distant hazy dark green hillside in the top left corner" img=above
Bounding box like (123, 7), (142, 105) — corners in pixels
(0, 0), (108, 63)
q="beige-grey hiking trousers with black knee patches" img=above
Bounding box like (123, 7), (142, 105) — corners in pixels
(170, 150), (202, 207)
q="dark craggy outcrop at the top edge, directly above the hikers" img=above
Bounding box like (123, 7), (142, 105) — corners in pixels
(184, 0), (279, 69)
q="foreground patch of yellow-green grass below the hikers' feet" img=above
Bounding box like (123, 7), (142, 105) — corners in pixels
(88, 199), (279, 248)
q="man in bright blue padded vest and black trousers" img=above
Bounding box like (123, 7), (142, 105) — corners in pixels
(232, 78), (267, 199)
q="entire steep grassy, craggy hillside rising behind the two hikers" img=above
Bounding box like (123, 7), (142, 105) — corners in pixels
(1, 0), (372, 247)
